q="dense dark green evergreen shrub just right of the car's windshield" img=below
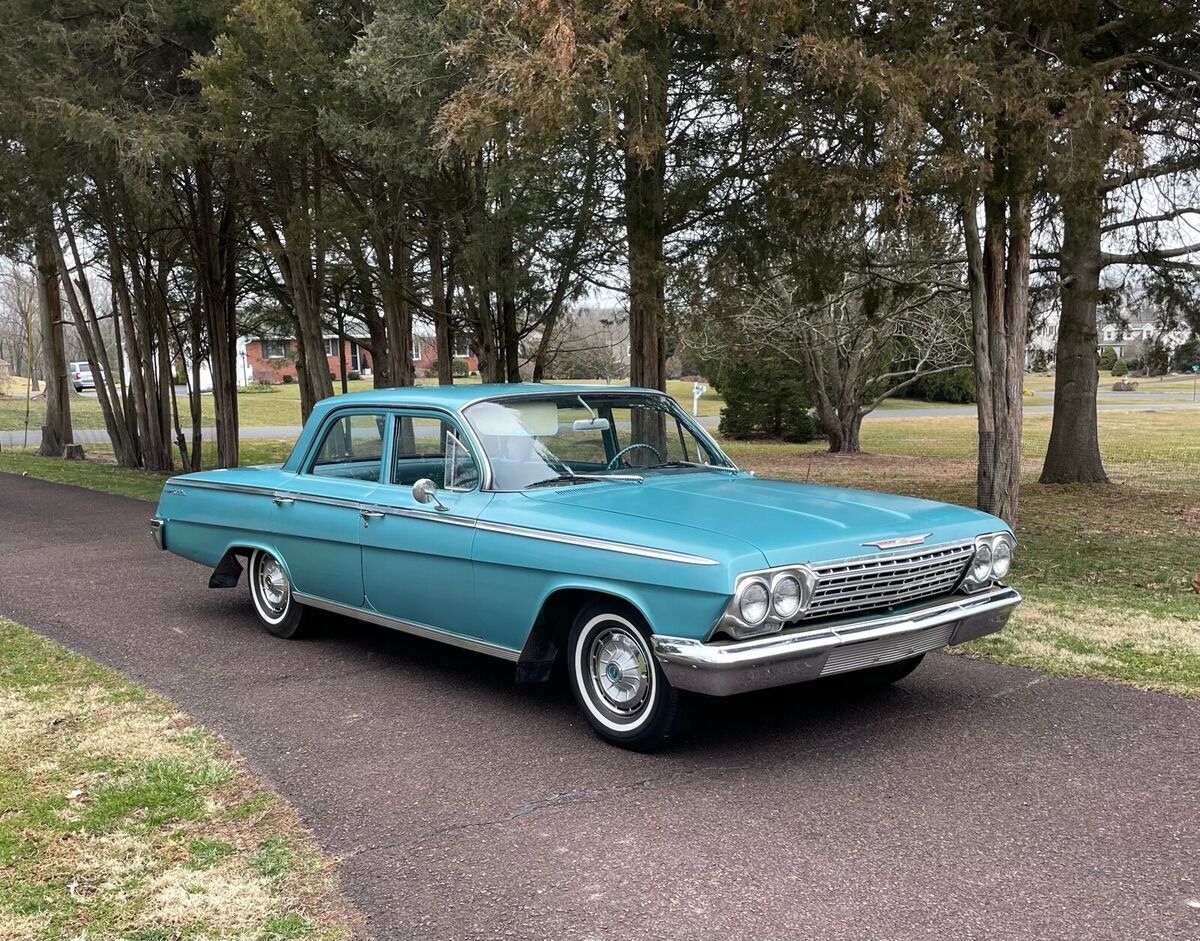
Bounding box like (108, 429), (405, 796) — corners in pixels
(707, 353), (821, 442)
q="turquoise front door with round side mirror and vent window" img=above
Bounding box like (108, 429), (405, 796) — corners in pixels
(360, 410), (492, 637)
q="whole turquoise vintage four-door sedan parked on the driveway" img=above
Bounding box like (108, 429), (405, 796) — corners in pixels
(151, 385), (1021, 749)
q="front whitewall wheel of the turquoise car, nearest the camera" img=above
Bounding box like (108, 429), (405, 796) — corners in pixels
(569, 604), (690, 751)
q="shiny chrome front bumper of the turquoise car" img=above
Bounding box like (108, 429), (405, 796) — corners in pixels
(652, 586), (1021, 696)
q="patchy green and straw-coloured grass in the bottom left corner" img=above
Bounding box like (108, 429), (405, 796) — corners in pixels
(0, 619), (362, 941)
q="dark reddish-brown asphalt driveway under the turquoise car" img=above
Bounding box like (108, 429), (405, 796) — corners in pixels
(0, 474), (1200, 941)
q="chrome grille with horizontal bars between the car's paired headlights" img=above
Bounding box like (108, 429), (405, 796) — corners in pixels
(804, 543), (974, 621)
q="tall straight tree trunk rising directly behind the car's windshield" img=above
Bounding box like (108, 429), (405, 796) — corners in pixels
(624, 31), (670, 450)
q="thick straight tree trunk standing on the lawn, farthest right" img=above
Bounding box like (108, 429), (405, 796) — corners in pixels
(1042, 191), (1109, 484)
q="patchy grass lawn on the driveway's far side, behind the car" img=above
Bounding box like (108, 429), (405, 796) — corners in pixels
(0, 409), (1200, 697)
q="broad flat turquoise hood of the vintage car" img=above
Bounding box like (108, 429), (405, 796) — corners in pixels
(527, 473), (1008, 565)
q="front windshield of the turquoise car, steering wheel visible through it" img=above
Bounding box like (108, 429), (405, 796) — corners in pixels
(463, 392), (736, 490)
